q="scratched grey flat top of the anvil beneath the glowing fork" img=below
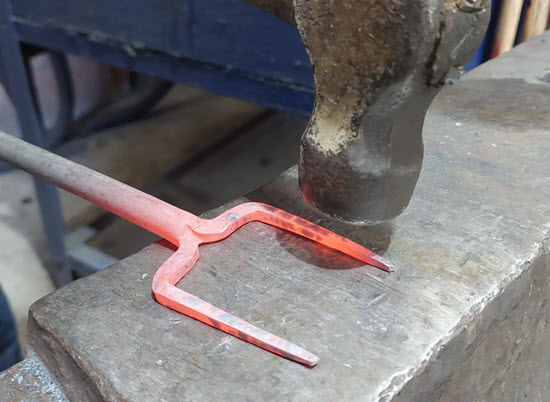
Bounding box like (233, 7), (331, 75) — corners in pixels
(30, 34), (550, 400)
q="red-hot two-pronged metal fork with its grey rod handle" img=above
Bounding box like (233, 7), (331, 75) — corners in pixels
(0, 132), (391, 367)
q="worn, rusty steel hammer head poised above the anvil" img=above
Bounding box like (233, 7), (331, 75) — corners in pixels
(294, 0), (490, 225)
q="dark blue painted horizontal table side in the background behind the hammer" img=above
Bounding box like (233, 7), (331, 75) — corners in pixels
(11, 0), (313, 114)
